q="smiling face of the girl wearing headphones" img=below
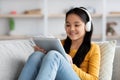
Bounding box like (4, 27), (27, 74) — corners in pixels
(65, 14), (85, 41)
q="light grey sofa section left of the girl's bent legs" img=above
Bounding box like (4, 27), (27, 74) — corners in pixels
(0, 40), (34, 80)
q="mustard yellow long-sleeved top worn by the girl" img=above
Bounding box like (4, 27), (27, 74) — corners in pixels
(62, 41), (100, 80)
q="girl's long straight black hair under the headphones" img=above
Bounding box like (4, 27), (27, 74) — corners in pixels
(64, 7), (93, 67)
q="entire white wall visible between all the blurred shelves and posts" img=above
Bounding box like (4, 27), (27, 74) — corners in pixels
(0, 0), (120, 35)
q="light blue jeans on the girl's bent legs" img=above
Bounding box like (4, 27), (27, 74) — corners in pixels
(18, 50), (80, 80)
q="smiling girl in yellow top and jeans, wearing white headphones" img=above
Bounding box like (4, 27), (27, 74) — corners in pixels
(18, 7), (100, 80)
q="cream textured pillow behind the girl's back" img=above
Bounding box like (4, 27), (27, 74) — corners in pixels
(98, 40), (116, 80)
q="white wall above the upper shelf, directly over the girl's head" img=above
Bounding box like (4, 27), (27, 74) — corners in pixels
(48, 0), (102, 13)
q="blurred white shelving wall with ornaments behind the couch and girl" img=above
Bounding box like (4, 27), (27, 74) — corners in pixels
(0, 0), (120, 45)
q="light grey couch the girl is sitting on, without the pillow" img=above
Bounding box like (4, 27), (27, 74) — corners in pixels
(0, 39), (120, 80)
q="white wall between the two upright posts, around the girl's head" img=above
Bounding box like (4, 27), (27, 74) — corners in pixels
(48, 0), (103, 35)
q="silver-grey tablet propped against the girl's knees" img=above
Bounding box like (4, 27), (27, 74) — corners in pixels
(33, 37), (67, 59)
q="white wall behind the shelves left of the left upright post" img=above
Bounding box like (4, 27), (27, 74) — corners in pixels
(0, 0), (44, 35)
